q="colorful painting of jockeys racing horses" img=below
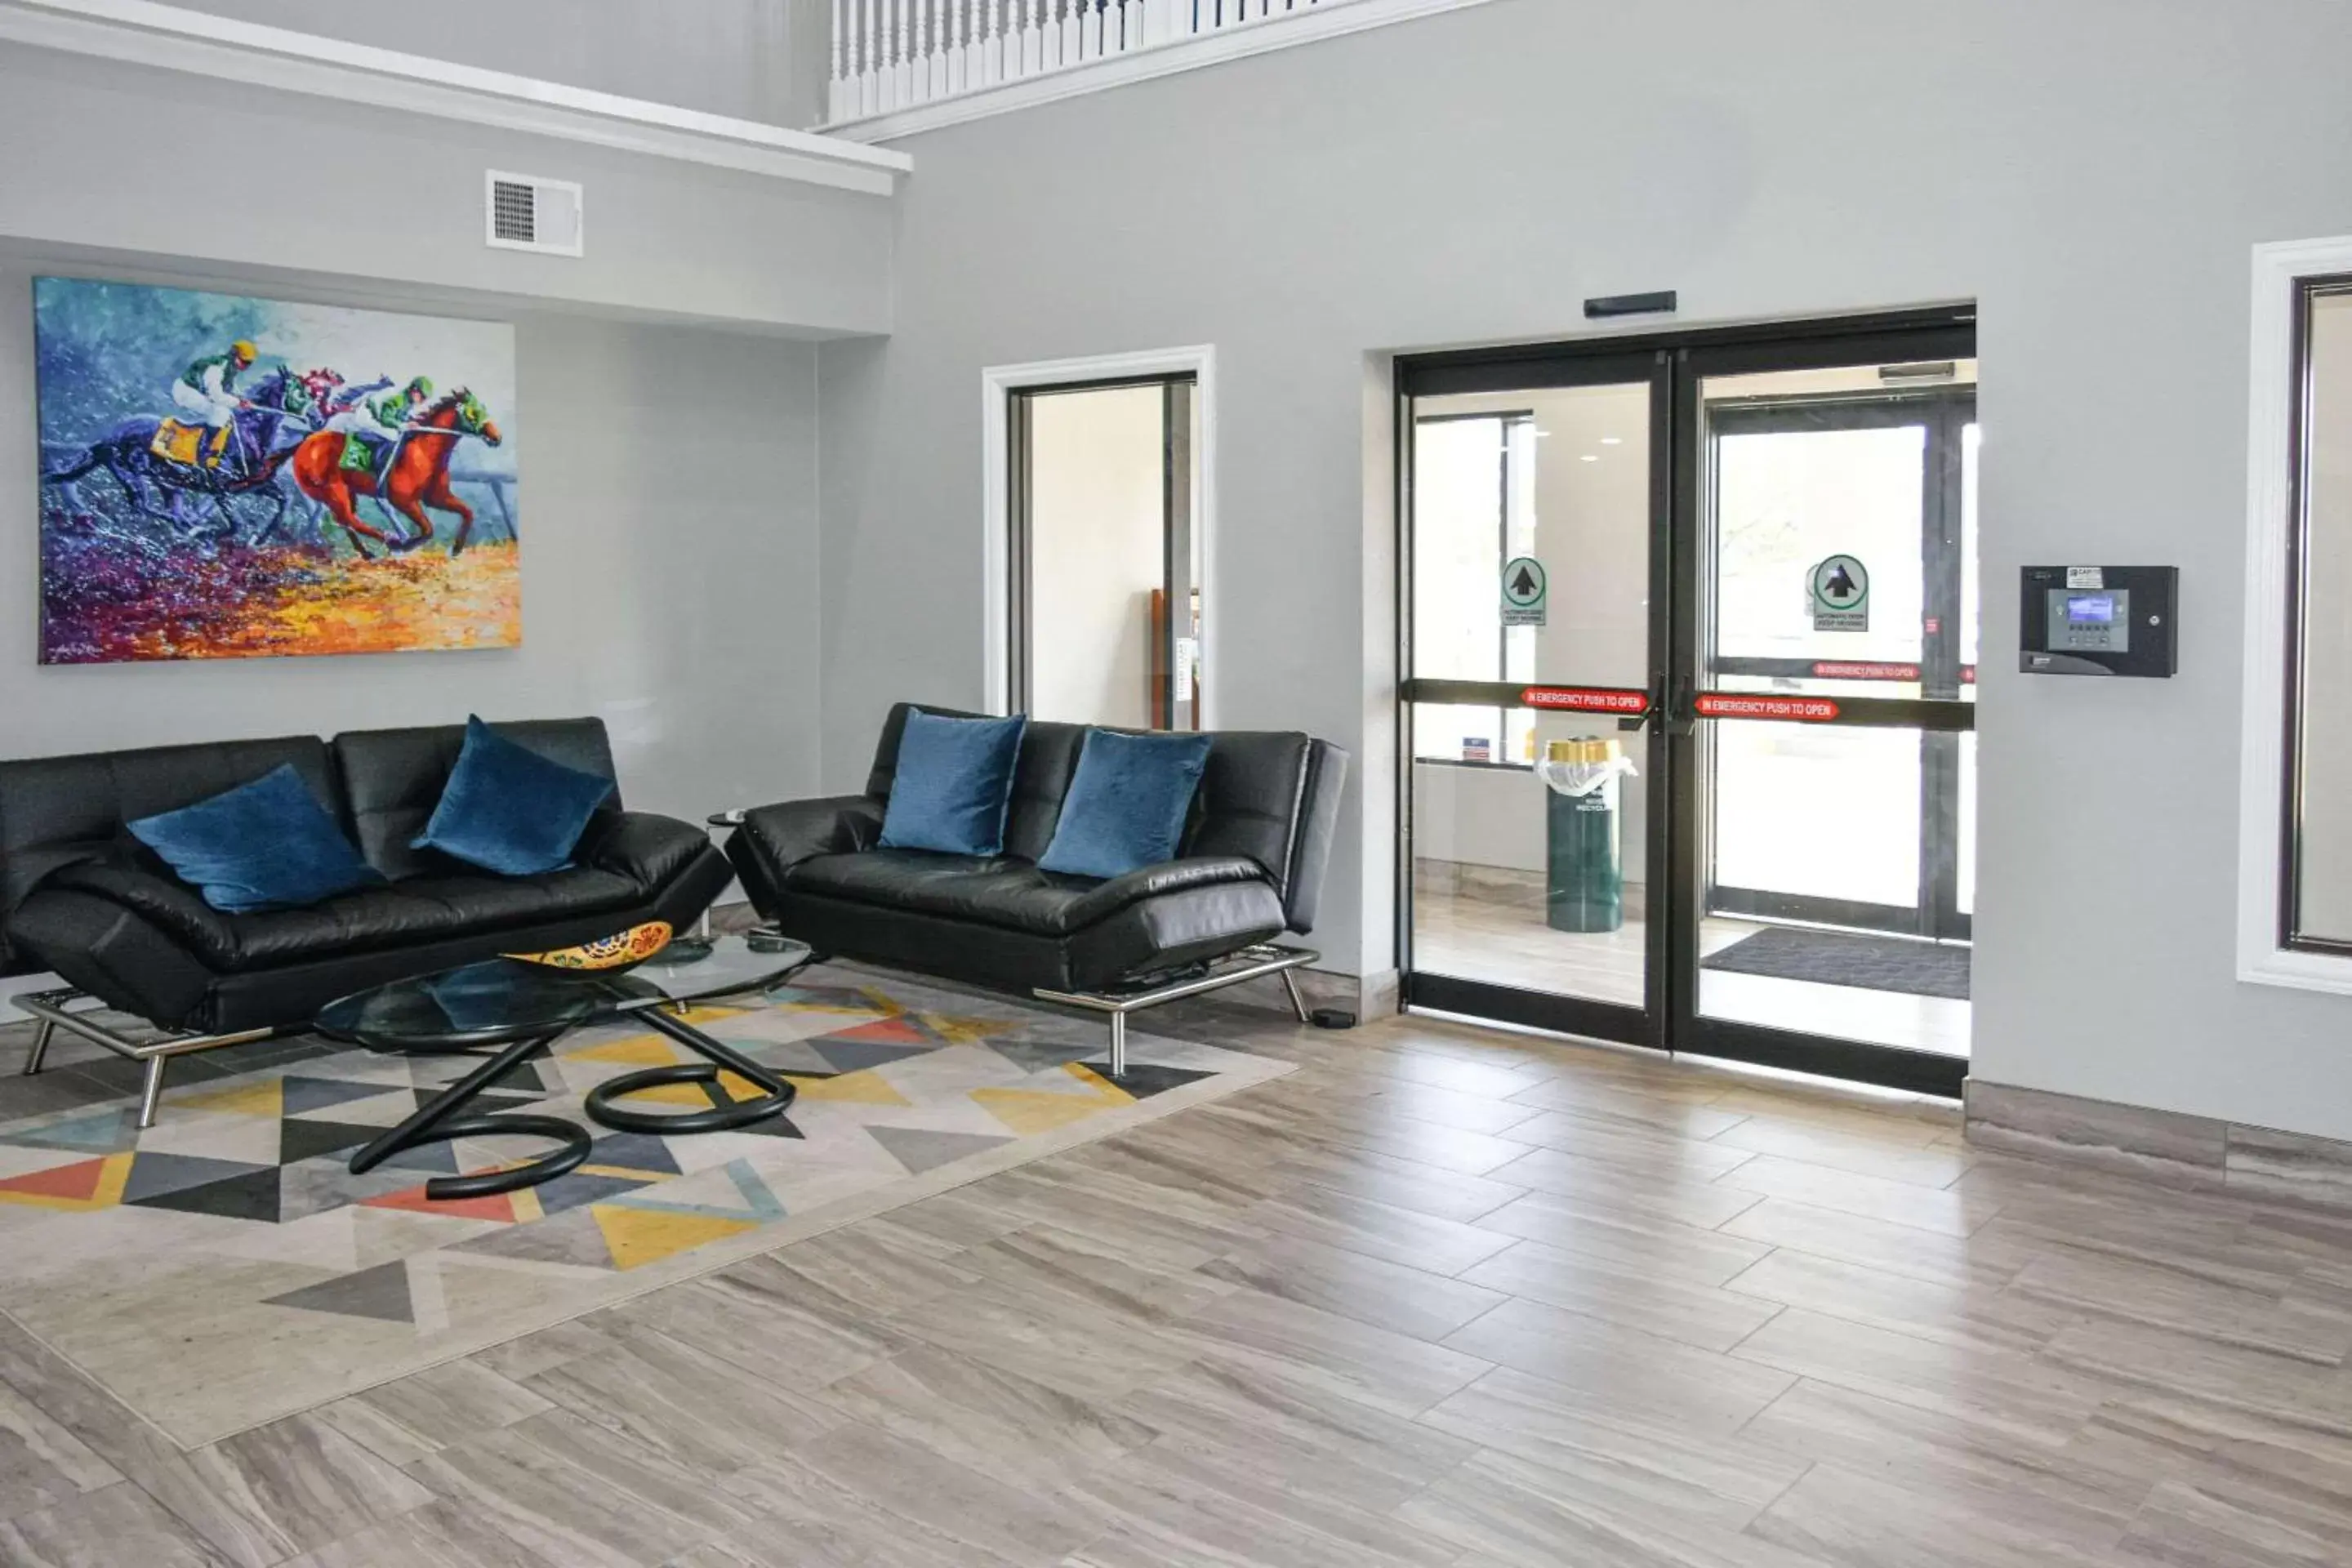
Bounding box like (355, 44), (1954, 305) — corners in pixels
(33, 278), (522, 666)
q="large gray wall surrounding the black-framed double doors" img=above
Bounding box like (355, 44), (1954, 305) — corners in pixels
(821, 0), (2352, 1135)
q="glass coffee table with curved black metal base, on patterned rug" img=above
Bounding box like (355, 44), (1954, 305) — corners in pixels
(313, 936), (812, 1199)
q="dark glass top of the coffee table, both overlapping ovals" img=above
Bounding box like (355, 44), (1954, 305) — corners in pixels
(313, 936), (809, 1051)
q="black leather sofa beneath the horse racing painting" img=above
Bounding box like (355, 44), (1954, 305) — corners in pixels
(0, 719), (732, 1126)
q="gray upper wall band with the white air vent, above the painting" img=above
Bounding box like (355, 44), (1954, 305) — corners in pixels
(0, 41), (892, 334)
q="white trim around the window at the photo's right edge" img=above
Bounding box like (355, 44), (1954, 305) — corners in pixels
(2237, 235), (2352, 995)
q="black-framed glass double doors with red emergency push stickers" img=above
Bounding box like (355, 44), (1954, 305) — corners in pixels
(1400, 318), (1978, 1094)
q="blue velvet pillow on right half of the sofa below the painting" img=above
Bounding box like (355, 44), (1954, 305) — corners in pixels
(409, 717), (612, 877)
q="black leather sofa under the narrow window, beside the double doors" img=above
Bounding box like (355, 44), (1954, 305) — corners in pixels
(727, 703), (1348, 1070)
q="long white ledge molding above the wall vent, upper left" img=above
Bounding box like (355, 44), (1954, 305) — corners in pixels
(0, 0), (915, 195)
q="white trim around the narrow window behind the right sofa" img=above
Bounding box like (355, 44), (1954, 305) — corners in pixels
(981, 343), (1223, 728)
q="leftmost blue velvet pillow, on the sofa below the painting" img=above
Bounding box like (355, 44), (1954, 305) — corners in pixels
(125, 762), (383, 915)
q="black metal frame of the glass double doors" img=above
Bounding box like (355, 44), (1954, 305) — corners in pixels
(1395, 305), (1976, 1095)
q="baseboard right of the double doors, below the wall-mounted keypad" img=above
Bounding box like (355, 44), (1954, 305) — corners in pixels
(1967, 1079), (2352, 1215)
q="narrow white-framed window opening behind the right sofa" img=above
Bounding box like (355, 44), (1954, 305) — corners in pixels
(990, 362), (1209, 731)
